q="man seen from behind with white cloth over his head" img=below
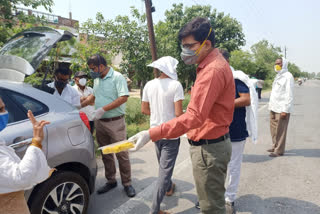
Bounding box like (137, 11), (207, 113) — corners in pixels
(141, 56), (184, 214)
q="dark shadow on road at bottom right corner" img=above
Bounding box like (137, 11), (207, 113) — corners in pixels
(235, 194), (320, 214)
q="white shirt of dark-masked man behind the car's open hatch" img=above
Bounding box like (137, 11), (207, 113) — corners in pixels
(48, 82), (81, 108)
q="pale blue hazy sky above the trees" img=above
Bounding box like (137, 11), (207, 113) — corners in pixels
(23, 0), (320, 73)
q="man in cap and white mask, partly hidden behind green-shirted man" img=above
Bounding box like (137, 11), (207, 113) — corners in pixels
(73, 71), (95, 134)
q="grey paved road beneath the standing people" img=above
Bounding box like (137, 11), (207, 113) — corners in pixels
(88, 80), (320, 214)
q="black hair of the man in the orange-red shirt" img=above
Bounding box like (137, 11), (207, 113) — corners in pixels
(178, 17), (215, 47)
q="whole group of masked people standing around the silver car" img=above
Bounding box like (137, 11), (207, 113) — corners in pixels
(0, 18), (294, 214)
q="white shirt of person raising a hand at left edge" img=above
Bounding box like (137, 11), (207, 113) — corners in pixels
(0, 142), (50, 194)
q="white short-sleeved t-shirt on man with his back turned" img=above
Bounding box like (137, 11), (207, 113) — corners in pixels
(142, 78), (184, 128)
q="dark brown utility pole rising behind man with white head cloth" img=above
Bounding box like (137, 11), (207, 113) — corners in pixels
(145, 0), (159, 77)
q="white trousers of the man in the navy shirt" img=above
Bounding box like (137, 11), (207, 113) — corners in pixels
(225, 140), (246, 202)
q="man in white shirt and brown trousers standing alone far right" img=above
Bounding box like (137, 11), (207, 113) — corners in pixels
(267, 58), (294, 157)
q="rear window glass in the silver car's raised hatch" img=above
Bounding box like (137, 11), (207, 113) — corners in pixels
(0, 28), (61, 69)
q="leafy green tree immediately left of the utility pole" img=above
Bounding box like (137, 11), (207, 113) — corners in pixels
(82, 7), (152, 90)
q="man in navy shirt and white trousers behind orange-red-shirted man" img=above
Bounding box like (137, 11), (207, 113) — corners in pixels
(220, 50), (258, 214)
